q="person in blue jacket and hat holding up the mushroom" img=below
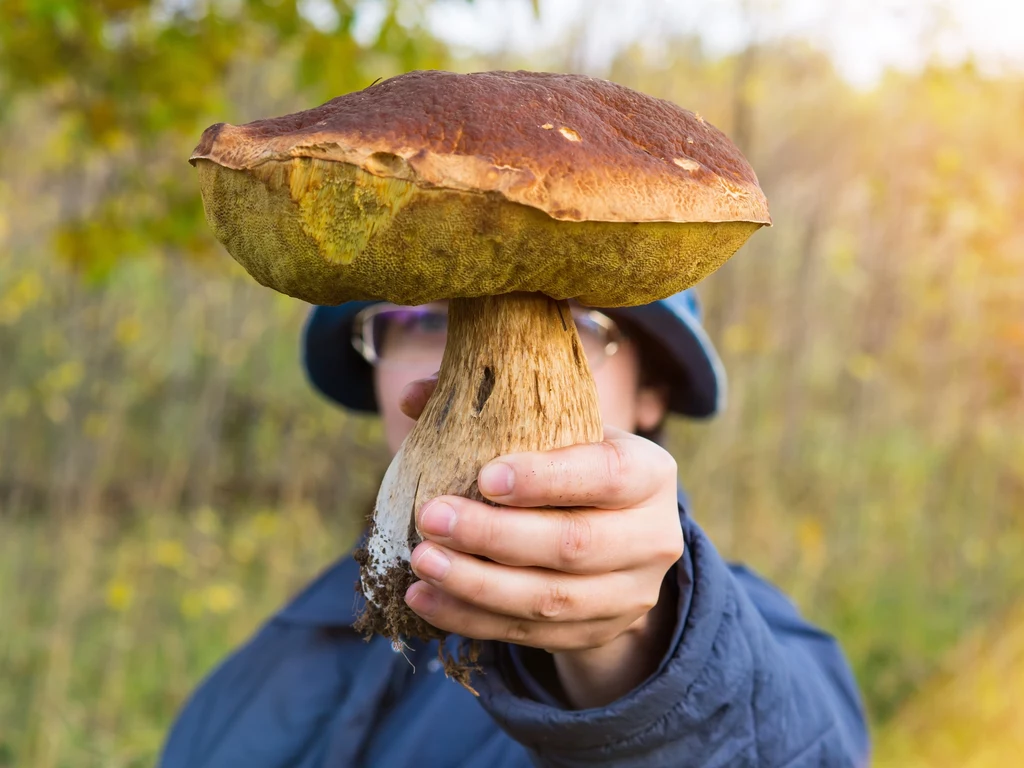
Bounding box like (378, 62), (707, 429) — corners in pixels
(160, 290), (868, 768)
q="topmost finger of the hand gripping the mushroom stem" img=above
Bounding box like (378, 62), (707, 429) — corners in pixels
(477, 430), (676, 509)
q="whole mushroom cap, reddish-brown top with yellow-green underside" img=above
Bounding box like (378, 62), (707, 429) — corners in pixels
(190, 72), (770, 306)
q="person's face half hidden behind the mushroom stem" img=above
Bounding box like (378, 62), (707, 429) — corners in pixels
(374, 303), (666, 456)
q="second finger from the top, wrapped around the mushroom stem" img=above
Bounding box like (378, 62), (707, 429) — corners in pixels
(417, 496), (683, 573)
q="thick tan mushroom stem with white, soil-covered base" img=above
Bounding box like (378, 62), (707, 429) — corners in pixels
(357, 293), (603, 643)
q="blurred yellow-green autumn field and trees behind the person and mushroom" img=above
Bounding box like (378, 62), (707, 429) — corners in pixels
(0, 0), (1024, 768)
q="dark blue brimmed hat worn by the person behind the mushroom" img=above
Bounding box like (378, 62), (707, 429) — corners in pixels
(302, 289), (726, 418)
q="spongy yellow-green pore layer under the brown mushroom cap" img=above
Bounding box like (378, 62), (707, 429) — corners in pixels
(196, 158), (761, 307)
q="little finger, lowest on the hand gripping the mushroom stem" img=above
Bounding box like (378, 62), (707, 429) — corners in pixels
(406, 582), (624, 652)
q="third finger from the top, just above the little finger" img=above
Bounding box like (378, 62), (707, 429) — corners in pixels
(412, 542), (638, 622)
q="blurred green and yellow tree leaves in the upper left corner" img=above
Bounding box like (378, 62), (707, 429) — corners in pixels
(0, 0), (456, 281)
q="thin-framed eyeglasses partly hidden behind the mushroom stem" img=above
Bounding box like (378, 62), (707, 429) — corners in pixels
(352, 303), (623, 369)
